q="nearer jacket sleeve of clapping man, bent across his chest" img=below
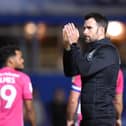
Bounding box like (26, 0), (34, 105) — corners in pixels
(71, 44), (119, 76)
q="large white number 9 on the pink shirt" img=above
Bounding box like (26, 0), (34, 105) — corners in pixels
(0, 85), (17, 109)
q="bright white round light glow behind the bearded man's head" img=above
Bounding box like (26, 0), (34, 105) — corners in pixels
(107, 21), (124, 37)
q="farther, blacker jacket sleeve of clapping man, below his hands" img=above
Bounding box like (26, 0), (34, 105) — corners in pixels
(63, 50), (79, 77)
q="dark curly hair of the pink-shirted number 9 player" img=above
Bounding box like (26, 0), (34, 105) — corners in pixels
(0, 45), (20, 66)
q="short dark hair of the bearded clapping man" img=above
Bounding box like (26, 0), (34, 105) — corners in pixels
(85, 12), (108, 32)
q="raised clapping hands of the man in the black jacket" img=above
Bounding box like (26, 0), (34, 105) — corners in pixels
(63, 23), (79, 44)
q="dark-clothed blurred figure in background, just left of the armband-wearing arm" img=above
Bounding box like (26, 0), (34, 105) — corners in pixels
(49, 88), (66, 126)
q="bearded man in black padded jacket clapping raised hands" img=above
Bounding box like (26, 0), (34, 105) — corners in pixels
(63, 13), (120, 126)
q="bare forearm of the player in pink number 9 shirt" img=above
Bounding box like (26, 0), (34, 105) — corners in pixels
(24, 99), (36, 126)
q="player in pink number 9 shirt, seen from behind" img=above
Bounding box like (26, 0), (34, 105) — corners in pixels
(0, 44), (36, 126)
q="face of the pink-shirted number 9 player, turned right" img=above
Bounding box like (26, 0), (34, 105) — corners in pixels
(12, 50), (24, 69)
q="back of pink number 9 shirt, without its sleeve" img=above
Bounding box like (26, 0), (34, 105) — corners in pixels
(0, 67), (31, 126)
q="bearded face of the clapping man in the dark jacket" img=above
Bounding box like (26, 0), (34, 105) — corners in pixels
(83, 18), (99, 43)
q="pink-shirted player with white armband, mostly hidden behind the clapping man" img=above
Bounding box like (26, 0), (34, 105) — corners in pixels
(67, 69), (124, 126)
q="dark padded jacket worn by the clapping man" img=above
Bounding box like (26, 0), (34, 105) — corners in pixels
(63, 39), (119, 126)
